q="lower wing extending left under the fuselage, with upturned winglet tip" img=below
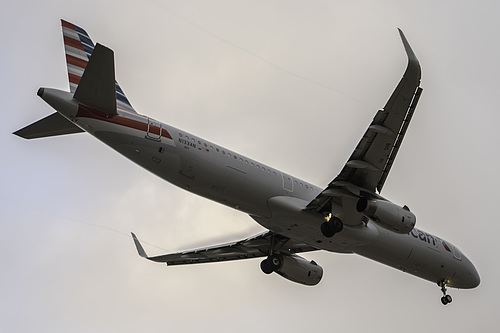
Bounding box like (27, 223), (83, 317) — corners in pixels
(132, 231), (317, 266)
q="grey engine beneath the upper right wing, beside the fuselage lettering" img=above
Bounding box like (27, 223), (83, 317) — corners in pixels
(356, 198), (417, 234)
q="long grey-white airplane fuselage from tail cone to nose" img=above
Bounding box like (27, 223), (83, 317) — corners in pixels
(41, 88), (479, 288)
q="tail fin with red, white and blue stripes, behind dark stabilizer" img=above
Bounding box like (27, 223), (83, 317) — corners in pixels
(61, 20), (135, 112)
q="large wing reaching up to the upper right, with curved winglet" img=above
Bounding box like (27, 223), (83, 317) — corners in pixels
(306, 30), (422, 217)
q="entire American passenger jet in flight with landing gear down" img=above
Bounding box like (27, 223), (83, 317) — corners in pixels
(13, 20), (480, 305)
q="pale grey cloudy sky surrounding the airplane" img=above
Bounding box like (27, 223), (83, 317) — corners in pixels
(0, 0), (500, 332)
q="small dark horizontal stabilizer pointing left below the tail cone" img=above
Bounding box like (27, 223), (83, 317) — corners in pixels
(14, 112), (83, 139)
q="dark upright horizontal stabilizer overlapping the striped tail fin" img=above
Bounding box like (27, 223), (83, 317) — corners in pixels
(73, 44), (117, 115)
